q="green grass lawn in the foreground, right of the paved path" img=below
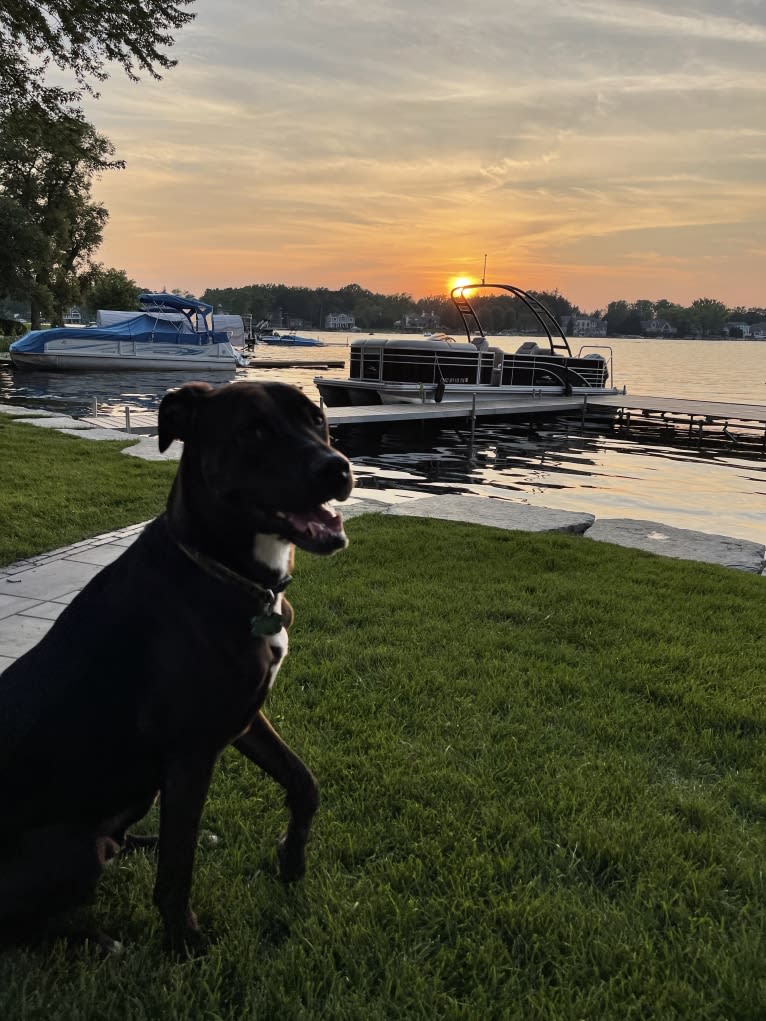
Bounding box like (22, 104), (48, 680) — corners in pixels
(0, 418), (766, 1021)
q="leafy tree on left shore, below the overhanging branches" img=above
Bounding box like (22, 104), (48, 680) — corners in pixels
(0, 101), (123, 327)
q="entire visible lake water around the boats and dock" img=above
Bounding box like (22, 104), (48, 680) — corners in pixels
(0, 337), (766, 543)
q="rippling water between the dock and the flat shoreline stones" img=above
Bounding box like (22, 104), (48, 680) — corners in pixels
(338, 414), (766, 542)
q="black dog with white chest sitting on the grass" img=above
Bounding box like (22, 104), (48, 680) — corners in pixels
(0, 383), (353, 952)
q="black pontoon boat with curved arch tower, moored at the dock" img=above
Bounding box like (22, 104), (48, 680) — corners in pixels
(314, 283), (617, 407)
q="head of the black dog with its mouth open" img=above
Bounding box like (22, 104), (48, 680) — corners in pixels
(159, 383), (353, 553)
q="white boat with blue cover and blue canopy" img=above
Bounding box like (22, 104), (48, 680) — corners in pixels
(10, 293), (247, 372)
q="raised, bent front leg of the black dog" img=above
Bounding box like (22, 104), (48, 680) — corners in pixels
(234, 713), (319, 882)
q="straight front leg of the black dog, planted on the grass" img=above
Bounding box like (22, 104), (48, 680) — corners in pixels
(154, 755), (217, 954)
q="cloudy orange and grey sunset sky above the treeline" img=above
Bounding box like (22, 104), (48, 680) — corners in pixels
(81, 0), (766, 311)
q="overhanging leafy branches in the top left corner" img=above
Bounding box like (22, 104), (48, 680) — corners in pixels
(0, 0), (194, 104)
